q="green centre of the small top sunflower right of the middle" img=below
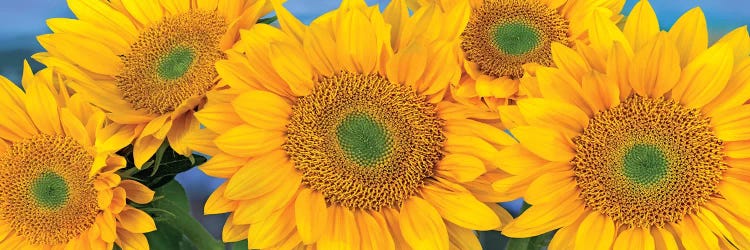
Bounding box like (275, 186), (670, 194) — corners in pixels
(492, 21), (539, 55)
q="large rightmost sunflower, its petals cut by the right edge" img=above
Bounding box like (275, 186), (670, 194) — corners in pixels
(494, 2), (750, 249)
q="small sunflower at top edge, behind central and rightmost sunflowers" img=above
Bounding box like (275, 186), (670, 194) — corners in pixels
(409, 0), (625, 110)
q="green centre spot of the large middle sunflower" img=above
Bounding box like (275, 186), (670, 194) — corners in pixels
(336, 112), (391, 166)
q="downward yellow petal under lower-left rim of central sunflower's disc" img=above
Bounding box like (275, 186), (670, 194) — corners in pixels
(294, 188), (328, 244)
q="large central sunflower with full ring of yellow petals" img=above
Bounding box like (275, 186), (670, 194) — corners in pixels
(188, 0), (513, 249)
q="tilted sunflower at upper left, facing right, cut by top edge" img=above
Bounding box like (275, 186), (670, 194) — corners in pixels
(34, 0), (278, 167)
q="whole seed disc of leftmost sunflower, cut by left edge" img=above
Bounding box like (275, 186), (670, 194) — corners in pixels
(0, 134), (101, 244)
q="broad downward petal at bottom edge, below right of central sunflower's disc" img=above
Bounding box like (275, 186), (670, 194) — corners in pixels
(398, 196), (449, 250)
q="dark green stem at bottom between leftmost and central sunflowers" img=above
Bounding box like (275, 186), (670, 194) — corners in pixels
(165, 203), (224, 250)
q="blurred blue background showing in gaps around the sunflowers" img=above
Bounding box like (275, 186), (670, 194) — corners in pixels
(0, 0), (750, 246)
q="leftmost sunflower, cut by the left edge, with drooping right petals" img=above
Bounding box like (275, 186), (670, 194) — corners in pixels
(0, 65), (156, 249)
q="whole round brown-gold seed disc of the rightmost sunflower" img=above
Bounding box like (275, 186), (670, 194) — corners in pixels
(571, 95), (727, 228)
